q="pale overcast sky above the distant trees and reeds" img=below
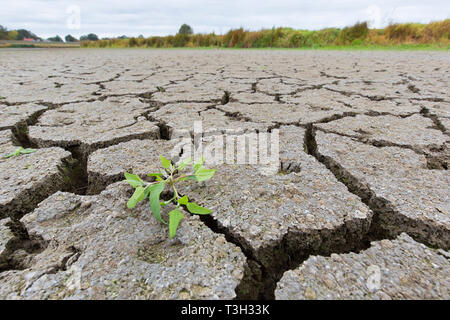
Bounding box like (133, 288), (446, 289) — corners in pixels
(0, 0), (450, 38)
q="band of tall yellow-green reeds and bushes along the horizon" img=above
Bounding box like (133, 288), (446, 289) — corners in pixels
(81, 19), (450, 48)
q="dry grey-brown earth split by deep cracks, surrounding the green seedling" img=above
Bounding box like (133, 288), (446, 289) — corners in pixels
(0, 49), (450, 299)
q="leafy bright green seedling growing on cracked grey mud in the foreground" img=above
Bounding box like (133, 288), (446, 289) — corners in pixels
(125, 156), (216, 238)
